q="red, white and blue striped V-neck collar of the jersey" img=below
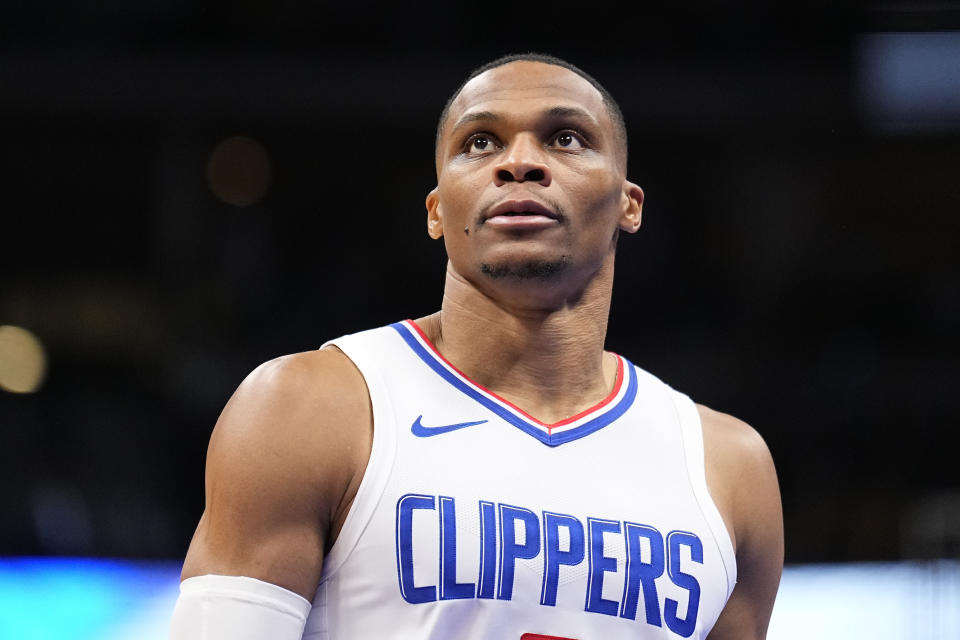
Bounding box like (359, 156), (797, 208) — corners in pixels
(390, 320), (637, 447)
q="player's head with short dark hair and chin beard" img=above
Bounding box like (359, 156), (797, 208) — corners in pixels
(427, 61), (643, 300)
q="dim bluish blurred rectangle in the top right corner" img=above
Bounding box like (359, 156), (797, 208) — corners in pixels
(858, 31), (960, 132)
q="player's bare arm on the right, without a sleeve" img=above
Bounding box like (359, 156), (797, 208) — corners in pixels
(698, 406), (783, 640)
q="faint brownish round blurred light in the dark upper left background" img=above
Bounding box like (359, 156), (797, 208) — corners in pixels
(207, 136), (271, 207)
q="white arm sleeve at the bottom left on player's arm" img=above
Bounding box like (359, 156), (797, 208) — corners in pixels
(170, 575), (311, 640)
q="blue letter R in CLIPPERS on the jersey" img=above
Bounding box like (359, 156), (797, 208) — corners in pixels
(620, 522), (664, 627)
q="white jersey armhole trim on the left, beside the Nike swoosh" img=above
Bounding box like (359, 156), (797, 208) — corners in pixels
(320, 336), (397, 585)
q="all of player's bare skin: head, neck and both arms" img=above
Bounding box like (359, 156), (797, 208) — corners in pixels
(182, 61), (783, 640)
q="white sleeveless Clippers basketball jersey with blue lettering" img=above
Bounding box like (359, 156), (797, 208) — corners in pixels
(304, 321), (736, 640)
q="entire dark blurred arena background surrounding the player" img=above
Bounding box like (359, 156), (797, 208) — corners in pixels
(0, 0), (960, 639)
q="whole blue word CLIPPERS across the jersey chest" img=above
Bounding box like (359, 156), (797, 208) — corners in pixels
(396, 493), (704, 638)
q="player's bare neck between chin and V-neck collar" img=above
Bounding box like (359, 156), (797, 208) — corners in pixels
(417, 261), (617, 424)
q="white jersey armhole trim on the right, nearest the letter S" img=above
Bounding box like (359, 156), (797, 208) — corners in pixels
(673, 391), (737, 599)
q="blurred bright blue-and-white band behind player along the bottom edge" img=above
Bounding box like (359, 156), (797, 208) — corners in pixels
(0, 558), (960, 640)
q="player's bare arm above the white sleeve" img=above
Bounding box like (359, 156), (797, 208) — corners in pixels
(181, 349), (372, 600)
